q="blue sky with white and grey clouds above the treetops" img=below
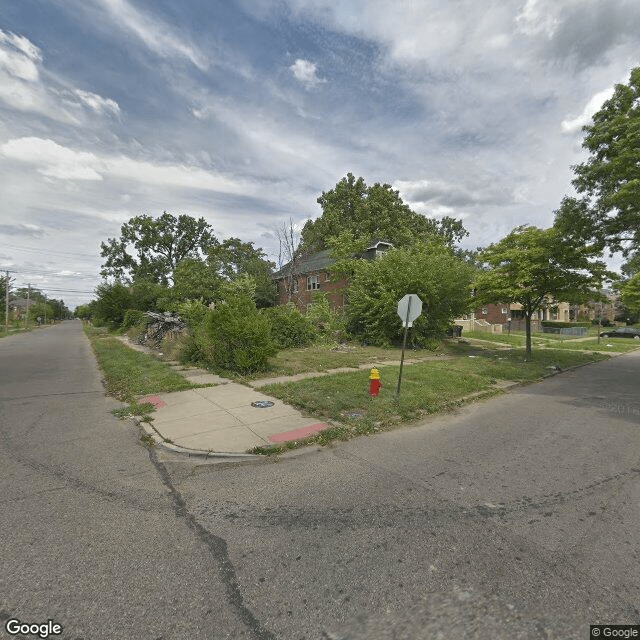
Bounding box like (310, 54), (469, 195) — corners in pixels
(0, 0), (640, 308)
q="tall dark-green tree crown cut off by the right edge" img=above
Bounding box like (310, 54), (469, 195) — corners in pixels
(556, 67), (640, 256)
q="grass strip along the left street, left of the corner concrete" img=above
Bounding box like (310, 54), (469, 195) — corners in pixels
(85, 327), (201, 404)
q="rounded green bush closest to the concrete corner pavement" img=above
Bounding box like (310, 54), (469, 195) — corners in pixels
(205, 296), (278, 375)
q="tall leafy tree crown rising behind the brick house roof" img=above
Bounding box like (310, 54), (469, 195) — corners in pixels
(301, 173), (467, 256)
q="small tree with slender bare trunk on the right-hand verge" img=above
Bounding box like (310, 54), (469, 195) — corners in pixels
(475, 225), (612, 356)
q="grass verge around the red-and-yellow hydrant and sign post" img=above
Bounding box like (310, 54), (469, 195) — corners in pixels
(260, 342), (608, 452)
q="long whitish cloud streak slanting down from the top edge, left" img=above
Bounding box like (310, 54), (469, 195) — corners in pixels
(98, 0), (209, 71)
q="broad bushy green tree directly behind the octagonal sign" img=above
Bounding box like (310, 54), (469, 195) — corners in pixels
(346, 241), (473, 345)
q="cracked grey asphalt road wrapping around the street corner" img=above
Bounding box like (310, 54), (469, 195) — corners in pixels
(0, 323), (640, 640)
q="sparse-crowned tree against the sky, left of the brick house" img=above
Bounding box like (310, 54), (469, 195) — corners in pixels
(100, 211), (217, 286)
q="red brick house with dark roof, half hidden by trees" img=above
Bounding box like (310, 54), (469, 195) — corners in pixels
(273, 240), (393, 313)
